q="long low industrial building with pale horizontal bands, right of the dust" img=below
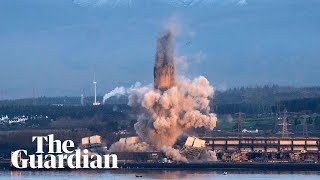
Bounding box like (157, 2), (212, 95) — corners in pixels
(203, 137), (320, 162)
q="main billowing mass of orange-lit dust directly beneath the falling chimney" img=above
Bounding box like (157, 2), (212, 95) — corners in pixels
(129, 76), (217, 150)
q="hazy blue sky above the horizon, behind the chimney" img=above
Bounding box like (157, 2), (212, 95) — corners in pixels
(0, 0), (320, 98)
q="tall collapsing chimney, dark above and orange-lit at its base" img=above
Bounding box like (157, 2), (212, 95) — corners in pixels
(154, 30), (176, 91)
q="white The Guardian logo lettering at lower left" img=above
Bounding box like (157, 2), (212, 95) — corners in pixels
(11, 134), (118, 169)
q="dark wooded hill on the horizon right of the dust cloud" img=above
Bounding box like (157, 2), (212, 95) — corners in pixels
(211, 85), (320, 114)
